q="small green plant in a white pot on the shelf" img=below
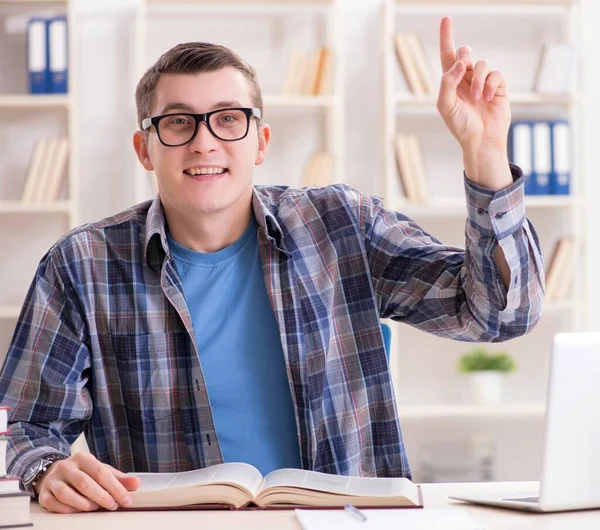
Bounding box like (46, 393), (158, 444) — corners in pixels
(458, 347), (516, 405)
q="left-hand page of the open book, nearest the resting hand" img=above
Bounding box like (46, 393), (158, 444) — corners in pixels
(131, 462), (262, 495)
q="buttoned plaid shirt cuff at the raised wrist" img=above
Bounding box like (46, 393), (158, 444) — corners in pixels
(464, 164), (525, 240)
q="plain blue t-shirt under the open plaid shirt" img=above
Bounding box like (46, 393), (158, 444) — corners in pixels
(169, 217), (300, 474)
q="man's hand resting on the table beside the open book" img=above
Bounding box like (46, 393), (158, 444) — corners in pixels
(35, 453), (140, 513)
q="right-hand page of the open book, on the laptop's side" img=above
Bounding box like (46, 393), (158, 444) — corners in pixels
(261, 469), (416, 498)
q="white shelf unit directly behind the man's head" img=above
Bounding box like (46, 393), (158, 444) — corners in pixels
(134, 0), (344, 202)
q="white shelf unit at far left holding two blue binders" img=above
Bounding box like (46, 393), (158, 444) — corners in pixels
(0, 0), (79, 336)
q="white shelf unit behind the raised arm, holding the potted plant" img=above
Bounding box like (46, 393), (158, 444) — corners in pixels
(381, 0), (586, 480)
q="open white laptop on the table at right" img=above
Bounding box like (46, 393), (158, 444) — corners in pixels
(450, 333), (600, 512)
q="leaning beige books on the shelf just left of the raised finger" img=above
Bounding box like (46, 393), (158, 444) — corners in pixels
(394, 32), (435, 94)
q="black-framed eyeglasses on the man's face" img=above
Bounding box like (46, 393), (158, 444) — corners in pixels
(142, 107), (261, 147)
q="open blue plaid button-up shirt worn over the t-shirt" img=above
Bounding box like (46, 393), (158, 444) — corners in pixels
(0, 168), (544, 477)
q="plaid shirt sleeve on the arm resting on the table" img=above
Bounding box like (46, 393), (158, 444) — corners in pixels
(0, 246), (92, 477)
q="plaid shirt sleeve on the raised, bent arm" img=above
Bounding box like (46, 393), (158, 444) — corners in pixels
(359, 166), (544, 342)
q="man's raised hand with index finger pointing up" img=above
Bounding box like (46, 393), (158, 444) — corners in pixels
(437, 17), (513, 190)
